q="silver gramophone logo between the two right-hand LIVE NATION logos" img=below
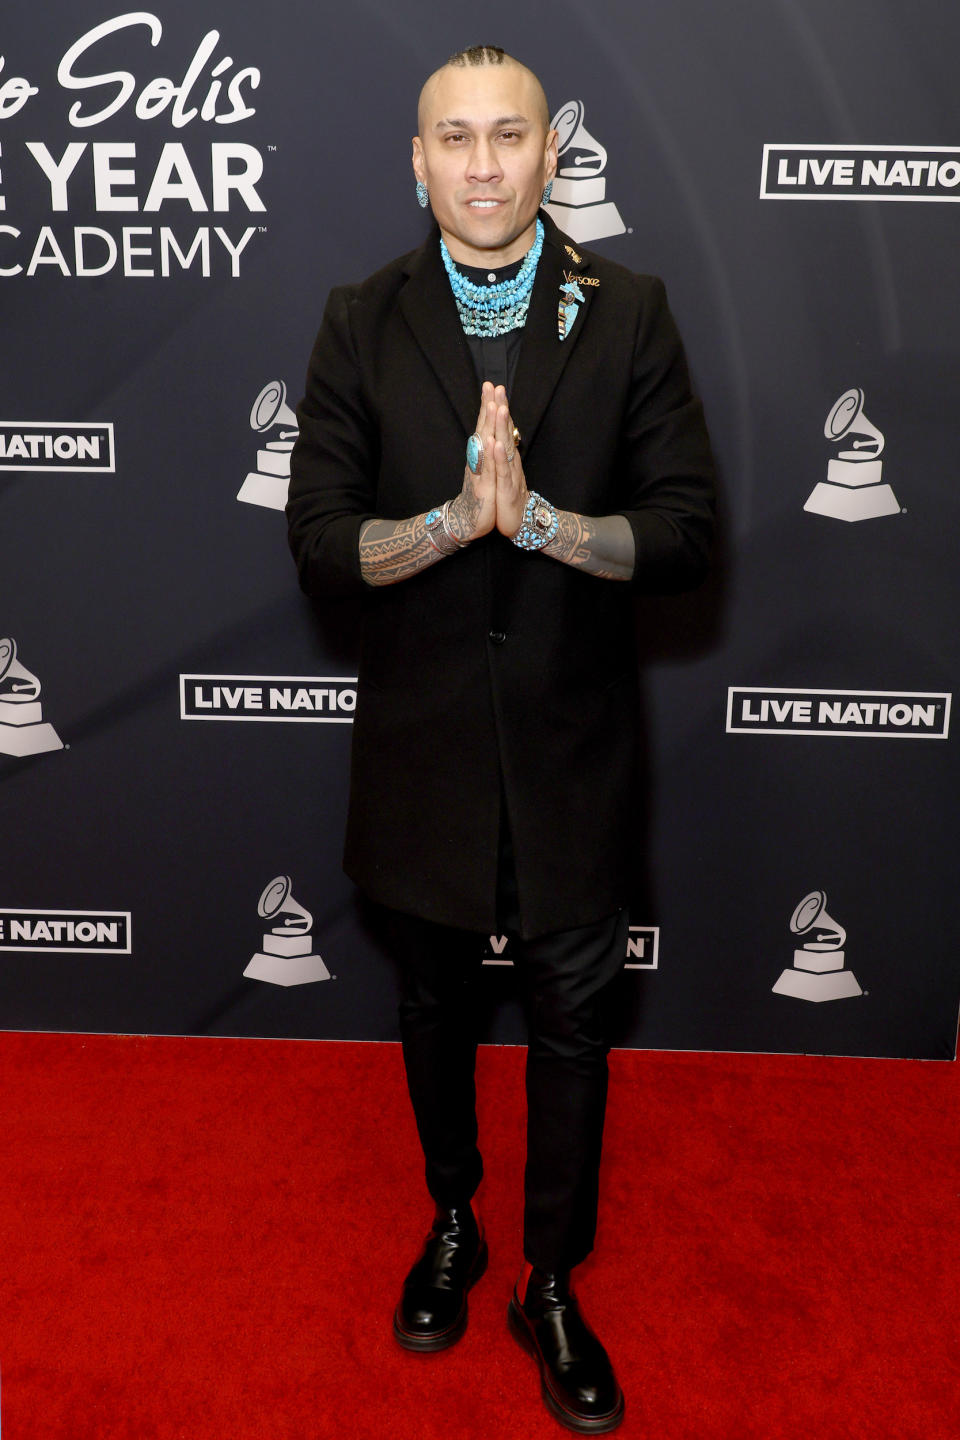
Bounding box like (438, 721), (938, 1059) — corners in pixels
(803, 386), (900, 520)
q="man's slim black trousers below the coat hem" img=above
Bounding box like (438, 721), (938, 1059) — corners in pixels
(390, 887), (629, 1272)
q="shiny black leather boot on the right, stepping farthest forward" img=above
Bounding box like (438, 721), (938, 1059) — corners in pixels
(507, 1264), (623, 1434)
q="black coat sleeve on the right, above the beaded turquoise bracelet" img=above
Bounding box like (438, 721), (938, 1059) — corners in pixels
(613, 276), (715, 595)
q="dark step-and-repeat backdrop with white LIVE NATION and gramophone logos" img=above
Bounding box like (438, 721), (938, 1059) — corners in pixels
(0, 0), (960, 1060)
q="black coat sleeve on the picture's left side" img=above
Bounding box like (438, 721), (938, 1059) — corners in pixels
(286, 287), (379, 596)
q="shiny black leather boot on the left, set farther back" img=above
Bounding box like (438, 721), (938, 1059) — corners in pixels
(393, 1204), (486, 1351)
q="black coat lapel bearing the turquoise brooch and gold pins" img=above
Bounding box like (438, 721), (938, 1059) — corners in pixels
(508, 212), (592, 451)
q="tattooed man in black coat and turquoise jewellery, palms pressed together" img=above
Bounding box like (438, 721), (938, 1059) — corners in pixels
(286, 46), (712, 1433)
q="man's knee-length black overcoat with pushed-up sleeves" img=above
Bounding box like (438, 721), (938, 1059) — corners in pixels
(286, 212), (714, 937)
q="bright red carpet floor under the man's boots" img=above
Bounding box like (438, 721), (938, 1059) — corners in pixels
(0, 1034), (960, 1440)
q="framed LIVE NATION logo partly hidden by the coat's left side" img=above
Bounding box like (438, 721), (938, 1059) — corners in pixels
(180, 675), (357, 724)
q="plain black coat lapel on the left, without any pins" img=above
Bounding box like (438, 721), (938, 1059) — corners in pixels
(399, 232), (479, 436)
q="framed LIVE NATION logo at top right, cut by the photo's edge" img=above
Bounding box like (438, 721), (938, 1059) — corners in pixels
(760, 144), (960, 203)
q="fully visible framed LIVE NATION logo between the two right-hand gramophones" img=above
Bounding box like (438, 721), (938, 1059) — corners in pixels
(727, 685), (951, 740)
